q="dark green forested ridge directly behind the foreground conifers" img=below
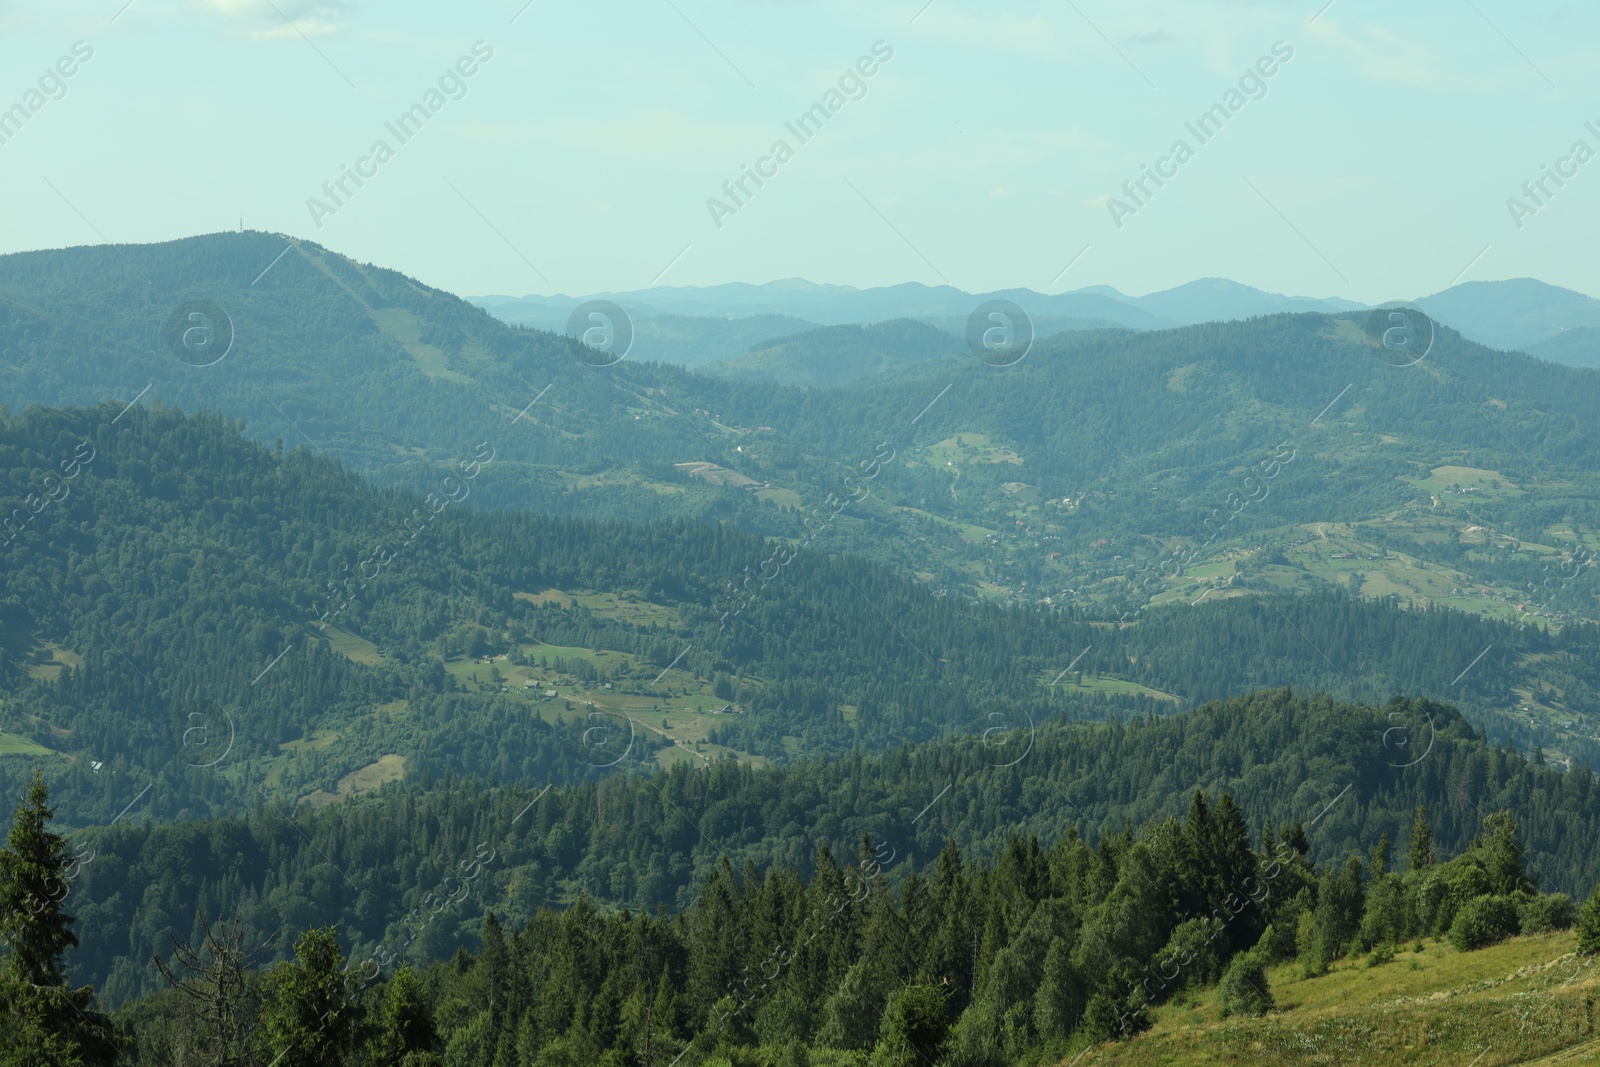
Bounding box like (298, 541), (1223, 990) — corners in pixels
(34, 689), (1600, 1005)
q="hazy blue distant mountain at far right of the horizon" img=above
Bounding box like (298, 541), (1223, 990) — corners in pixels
(1416, 278), (1600, 351)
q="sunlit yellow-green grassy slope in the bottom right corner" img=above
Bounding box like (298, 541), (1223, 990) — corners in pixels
(1061, 931), (1600, 1067)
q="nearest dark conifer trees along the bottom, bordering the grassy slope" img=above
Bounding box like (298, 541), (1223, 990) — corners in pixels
(9, 764), (1600, 1067)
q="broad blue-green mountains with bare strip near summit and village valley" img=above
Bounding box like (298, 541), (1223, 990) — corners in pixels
(9, 234), (1600, 771)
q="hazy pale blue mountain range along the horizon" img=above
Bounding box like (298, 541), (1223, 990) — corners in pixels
(472, 278), (1600, 371)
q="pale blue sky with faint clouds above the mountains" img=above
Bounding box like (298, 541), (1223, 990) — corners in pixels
(0, 0), (1600, 301)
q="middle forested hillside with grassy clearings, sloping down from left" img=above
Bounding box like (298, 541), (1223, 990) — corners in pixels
(0, 399), (1600, 824)
